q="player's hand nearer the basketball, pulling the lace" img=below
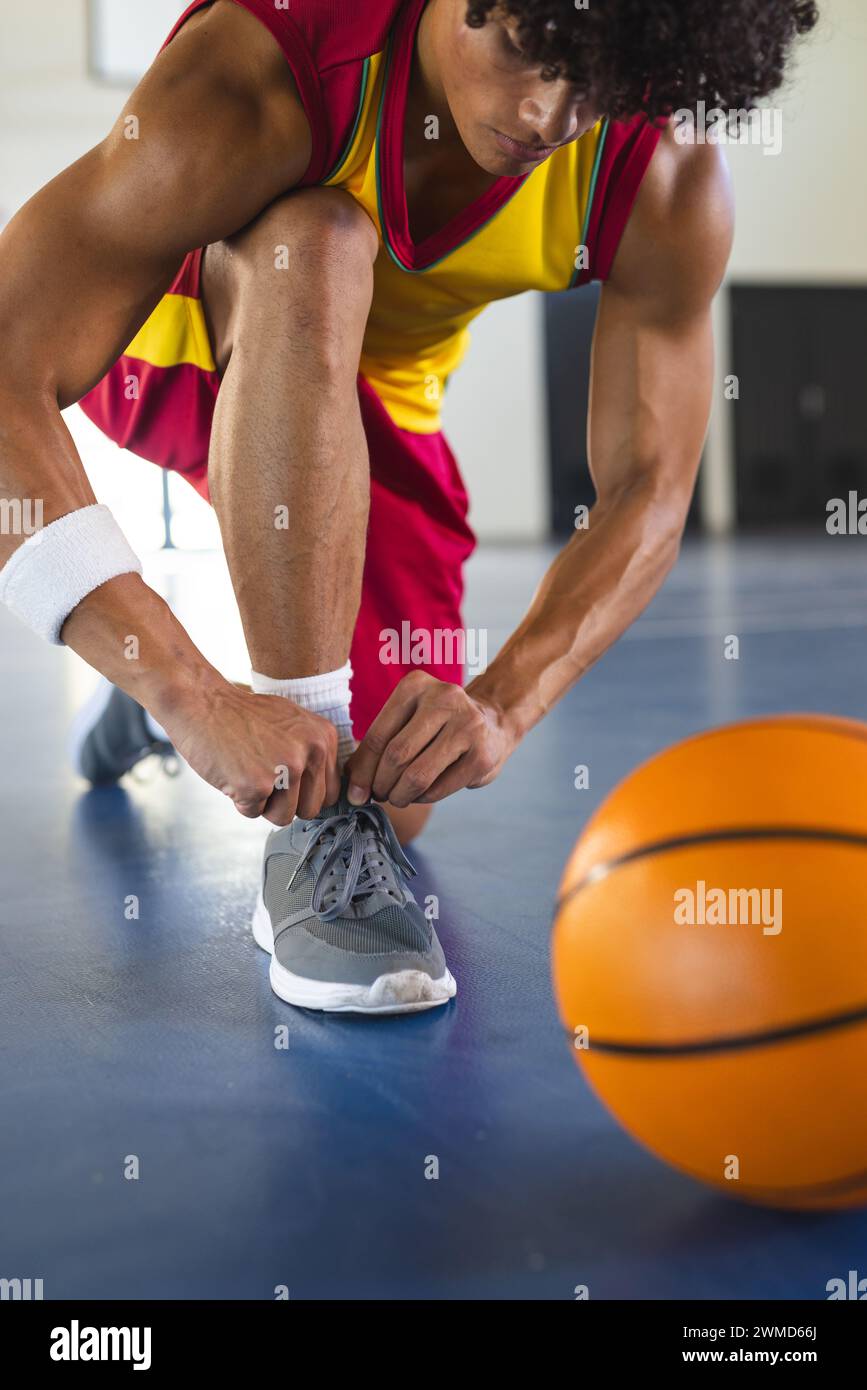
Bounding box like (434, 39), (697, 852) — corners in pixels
(341, 671), (515, 806)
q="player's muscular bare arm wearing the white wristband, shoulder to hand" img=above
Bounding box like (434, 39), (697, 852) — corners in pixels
(0, 0), (341, 815)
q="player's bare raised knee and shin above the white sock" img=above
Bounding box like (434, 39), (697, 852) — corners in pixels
(201, 189), (431, 844)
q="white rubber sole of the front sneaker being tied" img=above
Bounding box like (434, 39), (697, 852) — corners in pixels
(253, 892), (457, 1013)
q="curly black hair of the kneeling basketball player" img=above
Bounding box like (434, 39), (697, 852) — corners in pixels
(467, 0), (818, 120)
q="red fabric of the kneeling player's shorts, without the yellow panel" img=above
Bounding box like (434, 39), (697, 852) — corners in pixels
(81, 252), (475, 738)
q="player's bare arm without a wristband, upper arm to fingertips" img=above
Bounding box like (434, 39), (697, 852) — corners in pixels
(353, 136), (732, 806)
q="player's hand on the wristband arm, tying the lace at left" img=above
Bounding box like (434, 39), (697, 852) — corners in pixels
(157, 682), (340, 826)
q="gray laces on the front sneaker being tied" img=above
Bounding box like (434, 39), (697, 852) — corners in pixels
(292, 802), (415, 922)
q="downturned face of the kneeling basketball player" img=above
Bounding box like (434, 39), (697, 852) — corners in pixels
(438, 0), (600, 178)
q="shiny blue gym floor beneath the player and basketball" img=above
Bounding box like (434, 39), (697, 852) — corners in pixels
(0, 537), (867, 1300)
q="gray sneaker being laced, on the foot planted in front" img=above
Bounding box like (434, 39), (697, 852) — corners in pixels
(253, 795), (457, 1013)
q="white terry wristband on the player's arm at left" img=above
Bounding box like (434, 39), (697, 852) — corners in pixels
(0, 506), (142, 646)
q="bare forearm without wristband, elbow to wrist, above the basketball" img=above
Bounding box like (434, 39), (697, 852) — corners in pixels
(467, 482), (688, 741)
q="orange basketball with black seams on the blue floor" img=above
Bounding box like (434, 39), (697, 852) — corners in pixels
(553, 714), (867, 1208)
